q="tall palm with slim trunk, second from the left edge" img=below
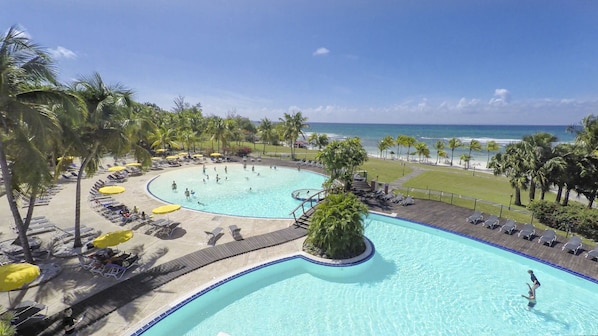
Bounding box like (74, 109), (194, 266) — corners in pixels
(69, 73), (137, 248)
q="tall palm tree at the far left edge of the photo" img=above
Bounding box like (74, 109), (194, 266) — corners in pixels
(0, 26), (77, 263)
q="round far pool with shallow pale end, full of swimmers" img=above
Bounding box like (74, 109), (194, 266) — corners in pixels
(148, 163), (327, 218)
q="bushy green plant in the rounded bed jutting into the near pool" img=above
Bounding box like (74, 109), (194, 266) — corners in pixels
(305, 193), (368, 259)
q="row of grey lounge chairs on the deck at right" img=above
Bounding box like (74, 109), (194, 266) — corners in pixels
(465, 211), (598, 259)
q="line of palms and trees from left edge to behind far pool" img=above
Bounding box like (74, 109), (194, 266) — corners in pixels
(0, 26), (314, 263)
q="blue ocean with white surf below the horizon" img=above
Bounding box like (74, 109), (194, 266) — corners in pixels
(304, 122), (575, 168)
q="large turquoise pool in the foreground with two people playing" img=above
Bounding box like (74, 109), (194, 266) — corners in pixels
(138, 215), (598, 336)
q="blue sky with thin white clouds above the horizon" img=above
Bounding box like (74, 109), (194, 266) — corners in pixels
(0, 0), (598, 125)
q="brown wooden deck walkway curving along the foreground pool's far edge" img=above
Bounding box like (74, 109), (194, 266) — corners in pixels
(20, 160), (598, 335)
